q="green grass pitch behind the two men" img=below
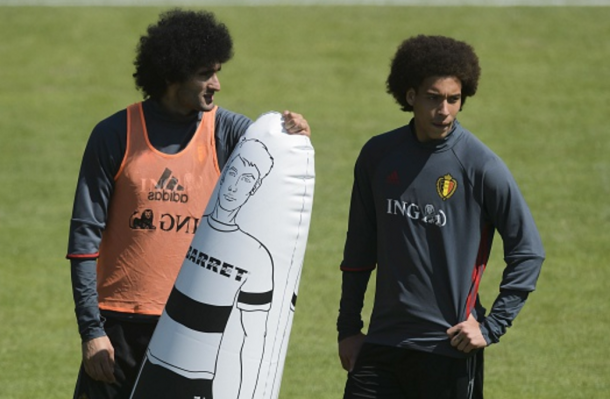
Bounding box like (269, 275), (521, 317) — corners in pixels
(0, 3), (610, 399)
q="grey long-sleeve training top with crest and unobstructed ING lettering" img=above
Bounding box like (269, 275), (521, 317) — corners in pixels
(337, 121), (545, 357)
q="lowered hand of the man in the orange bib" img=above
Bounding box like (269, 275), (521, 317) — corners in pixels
(82, 336), (116, 384)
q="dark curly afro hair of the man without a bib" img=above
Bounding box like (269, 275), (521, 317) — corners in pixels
(386, 35), (481, 112)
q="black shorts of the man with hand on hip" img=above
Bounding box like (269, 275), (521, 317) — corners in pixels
(343, 343), (483, 399)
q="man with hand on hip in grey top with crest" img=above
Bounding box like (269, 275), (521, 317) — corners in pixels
(337, 35), (545, 399)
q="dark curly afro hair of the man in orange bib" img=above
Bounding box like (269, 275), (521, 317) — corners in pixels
(133, 8), (233, 98)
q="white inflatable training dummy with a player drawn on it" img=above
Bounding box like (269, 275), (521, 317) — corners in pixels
(131, 112), (315, 399)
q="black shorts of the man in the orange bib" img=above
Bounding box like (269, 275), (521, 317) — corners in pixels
(74, 318), (156, 399)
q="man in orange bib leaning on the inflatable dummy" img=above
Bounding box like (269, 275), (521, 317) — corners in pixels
(67, 9), (310, 399)
